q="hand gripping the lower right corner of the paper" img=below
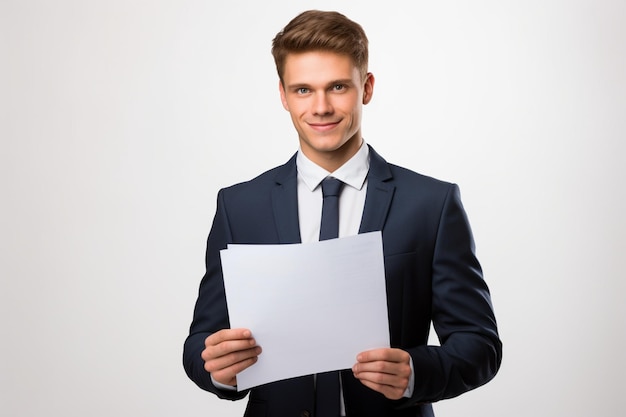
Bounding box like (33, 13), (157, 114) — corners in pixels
(352, 348), (411, 400)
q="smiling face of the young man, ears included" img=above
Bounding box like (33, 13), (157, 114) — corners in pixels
(279, 51), (374, 172)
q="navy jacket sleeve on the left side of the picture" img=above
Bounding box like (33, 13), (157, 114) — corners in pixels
(183, 190), (248, 400)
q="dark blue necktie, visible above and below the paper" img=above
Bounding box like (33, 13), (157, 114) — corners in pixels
(315, 177), (343, 417)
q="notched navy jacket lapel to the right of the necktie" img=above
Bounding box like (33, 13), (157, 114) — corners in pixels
(359, 146), (396, 233)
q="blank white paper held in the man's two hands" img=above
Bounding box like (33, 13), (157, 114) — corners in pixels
(220, 232), (389, 390)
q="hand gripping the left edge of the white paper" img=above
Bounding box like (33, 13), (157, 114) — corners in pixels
(202, 329), (261, 387)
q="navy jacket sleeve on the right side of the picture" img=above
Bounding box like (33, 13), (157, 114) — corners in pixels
(407, 184), (502, 404)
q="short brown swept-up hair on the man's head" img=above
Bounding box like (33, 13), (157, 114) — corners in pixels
(272, 10), (368, 82)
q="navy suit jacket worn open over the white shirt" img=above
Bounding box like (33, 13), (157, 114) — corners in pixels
(183, 148), (502, 417)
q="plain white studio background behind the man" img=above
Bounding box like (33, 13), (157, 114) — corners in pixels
(0, 0), (626, 417)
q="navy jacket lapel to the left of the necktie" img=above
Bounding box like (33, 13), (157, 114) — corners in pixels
(272, 155), (301, 243)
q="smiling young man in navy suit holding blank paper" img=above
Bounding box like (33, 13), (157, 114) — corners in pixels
(183, 11), (502, 417)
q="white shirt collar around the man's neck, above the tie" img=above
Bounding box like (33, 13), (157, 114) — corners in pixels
(296, 141), (370, 191)
